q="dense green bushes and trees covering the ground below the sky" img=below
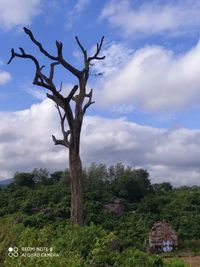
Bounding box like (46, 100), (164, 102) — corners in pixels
(0, 164), (197, 267)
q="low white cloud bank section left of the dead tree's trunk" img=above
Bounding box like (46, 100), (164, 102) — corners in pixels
(0, 100), (67, 178)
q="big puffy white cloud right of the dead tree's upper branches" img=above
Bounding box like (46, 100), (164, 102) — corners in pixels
(95, 43), (200, 112)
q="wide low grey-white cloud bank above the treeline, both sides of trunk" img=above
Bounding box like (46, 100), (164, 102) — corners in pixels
(0, 100), (200, 185)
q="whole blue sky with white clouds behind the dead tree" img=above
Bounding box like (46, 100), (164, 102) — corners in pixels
(0, 0), (200, 185)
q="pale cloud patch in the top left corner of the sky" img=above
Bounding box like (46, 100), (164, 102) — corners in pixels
(0, 0), (41, 30)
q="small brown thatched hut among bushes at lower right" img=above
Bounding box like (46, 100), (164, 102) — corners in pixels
(149, 222), (178, 252)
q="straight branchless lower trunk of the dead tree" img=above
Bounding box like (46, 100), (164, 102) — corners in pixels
(69, 148), (84, 225)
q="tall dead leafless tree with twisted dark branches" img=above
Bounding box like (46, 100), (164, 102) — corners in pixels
(8, 28), (105, 225)
